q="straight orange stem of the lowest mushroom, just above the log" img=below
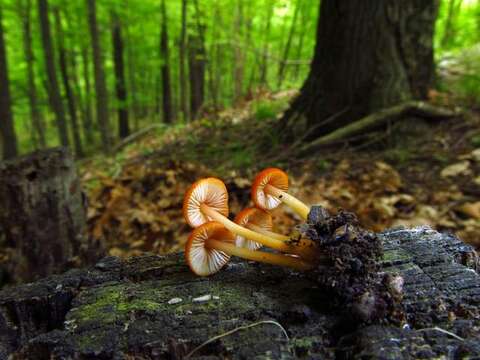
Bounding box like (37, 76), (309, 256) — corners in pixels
(205, 239), (314, 271)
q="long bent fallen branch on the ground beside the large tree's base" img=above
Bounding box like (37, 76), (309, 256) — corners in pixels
(300, 101), (459, 152)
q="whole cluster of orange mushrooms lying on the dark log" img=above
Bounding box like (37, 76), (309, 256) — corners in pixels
(183, 168), (318, 276)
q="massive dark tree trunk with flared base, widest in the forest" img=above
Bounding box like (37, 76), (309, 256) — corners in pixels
(283, 0), (438, 135)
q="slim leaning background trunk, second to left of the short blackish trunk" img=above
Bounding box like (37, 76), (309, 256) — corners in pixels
(53, 7), (83, 158)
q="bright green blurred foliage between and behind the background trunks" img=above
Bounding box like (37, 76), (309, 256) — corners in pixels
(1, 0), (480, 158)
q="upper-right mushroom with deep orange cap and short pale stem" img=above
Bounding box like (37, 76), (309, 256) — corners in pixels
(252, 168), (310, 220)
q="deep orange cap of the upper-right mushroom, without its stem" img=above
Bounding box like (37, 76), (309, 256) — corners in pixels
(251, 168), (288, 210)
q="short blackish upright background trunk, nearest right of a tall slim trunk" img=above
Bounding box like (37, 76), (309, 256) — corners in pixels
(111, 12), (130, 139)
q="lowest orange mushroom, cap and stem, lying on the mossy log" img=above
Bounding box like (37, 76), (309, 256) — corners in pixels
(185, 221), (313, 276)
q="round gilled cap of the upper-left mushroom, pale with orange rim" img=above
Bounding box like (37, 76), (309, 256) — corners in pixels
(183, 177), (228, 227)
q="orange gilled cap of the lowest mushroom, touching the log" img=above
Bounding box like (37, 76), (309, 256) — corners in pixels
(185, 221), (235, 276)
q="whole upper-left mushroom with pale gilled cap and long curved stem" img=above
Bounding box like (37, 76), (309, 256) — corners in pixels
(183, 178), (312, 256)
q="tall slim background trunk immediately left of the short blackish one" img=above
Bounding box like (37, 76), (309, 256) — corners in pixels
(86, 0), (110, 153)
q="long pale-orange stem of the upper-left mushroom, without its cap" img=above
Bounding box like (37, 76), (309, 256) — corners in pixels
(200, 204), (315, 258)
